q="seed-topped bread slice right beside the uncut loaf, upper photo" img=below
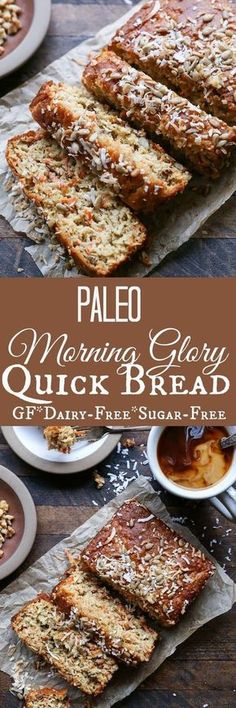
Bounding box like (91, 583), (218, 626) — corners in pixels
(83, 49), (236, 178)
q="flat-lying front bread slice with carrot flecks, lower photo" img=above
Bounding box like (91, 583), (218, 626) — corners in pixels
(12, 594), (117, 696)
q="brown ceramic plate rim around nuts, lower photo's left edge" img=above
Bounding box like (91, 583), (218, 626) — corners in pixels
(0, 465), (37, 580)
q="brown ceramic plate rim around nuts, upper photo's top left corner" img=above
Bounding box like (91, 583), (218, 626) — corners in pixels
(0, 0), (51, 78)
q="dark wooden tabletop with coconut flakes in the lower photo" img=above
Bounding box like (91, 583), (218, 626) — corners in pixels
(0, 432), (236, 708)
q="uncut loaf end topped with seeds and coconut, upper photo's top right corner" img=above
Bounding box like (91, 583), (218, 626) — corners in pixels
(110, 0), (236, 125)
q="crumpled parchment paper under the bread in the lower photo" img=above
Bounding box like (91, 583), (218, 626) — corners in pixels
(0, 476), (236, 708)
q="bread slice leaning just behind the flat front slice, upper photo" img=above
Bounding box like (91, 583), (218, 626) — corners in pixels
(30, 81), (190, 211)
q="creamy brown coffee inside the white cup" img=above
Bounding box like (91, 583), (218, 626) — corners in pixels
(157, 426), (234, 489)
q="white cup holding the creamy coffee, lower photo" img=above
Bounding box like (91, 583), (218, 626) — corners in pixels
(147, 426), (236, 500)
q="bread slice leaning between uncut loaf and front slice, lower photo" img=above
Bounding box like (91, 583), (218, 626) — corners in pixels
(52, 559), (158, 665)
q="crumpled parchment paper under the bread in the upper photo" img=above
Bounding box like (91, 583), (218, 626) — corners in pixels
(0, 2), (236, 277)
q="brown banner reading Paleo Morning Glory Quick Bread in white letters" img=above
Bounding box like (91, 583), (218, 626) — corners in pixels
(0, 278), (236, 427)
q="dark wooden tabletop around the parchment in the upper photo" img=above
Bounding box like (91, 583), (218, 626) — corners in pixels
(0, 0), (236, 278)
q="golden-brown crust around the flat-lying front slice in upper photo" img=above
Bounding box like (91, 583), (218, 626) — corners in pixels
(6, 130), (147, 277)
